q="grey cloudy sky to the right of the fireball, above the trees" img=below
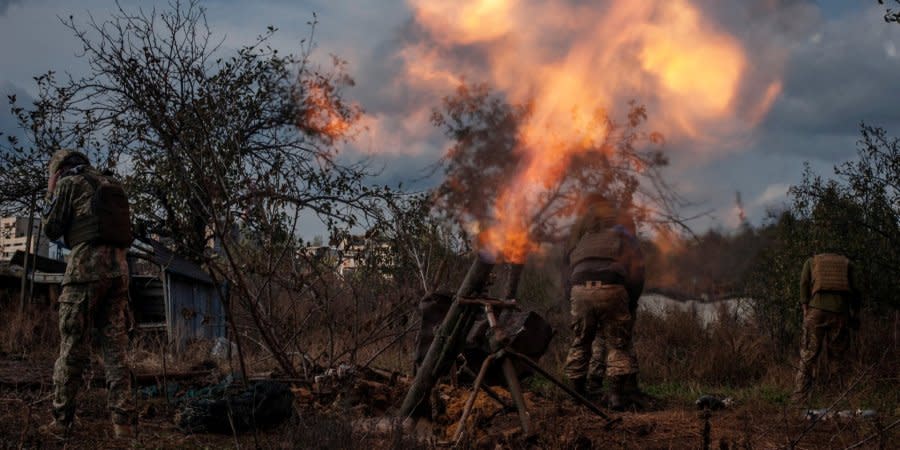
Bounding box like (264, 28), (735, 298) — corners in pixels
(624, 0), (900, 230)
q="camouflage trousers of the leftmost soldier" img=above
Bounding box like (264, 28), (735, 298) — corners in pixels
(53, 277), (134, 425)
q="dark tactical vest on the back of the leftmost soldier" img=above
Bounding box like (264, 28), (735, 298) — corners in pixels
(66, 173), (134, 248)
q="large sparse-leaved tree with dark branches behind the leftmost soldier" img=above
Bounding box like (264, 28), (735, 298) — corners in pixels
(0, 0), (394, 374)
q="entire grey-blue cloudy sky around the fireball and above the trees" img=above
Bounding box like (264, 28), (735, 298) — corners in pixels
(0, 0), (900, 229)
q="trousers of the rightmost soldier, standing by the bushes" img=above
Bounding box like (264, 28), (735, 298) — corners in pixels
(792, 308), (850, 402)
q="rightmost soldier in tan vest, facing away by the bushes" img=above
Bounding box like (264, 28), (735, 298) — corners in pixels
(792, 253), (859, 403)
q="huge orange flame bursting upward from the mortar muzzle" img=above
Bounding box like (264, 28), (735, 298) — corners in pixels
(402, 0), (781, 261)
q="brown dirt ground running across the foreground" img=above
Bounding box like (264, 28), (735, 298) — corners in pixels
(0, 358), (900, 449)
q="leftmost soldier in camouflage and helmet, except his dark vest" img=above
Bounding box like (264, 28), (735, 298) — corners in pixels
(43, 150), (134, 437)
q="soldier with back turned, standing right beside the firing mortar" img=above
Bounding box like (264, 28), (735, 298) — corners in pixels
(565, 196), (643, 410)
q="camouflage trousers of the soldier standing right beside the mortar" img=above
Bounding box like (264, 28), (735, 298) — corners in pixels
(565, 284), (638, 380)
